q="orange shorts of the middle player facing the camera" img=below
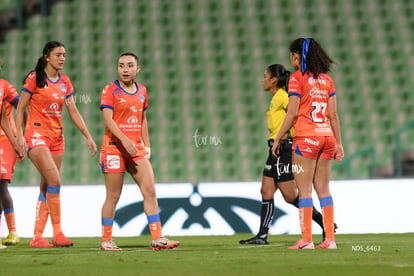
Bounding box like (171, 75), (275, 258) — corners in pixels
(99, 151), (148, 173)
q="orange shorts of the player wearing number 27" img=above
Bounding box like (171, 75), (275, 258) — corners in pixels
(292, 136), (335, 159)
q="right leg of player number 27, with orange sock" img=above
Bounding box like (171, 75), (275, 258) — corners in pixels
(313, 157), (336, 249)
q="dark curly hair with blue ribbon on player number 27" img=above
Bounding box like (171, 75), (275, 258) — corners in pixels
(289, 38), (335, 76)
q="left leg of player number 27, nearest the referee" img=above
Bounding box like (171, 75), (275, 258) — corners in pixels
(289, 153), (316, 249)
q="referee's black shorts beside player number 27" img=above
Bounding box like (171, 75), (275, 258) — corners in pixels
(263, 138), (294, 183)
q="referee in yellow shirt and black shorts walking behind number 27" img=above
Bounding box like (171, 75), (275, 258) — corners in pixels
(240, 64), (323, 244)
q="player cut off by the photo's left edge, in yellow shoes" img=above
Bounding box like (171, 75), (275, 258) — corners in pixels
(0, 59), (24, 245)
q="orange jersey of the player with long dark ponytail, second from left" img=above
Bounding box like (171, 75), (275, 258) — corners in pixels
(23, 72), (75, 138)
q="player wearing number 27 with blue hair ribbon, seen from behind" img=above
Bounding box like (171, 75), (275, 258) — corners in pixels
(272, 38), (344, 249)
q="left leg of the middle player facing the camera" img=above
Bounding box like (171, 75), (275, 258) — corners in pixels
(101, 172), (124, 251)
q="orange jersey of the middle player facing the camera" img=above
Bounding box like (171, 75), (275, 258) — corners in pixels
(100, 80), (148, 154)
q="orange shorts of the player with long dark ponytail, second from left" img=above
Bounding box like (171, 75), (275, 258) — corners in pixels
(24, 131), (65, 155)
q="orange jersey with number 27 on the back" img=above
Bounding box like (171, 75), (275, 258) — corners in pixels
(288, 71), (336, 137)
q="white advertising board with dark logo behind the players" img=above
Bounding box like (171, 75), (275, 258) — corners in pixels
(0, 179), (414, 237)
